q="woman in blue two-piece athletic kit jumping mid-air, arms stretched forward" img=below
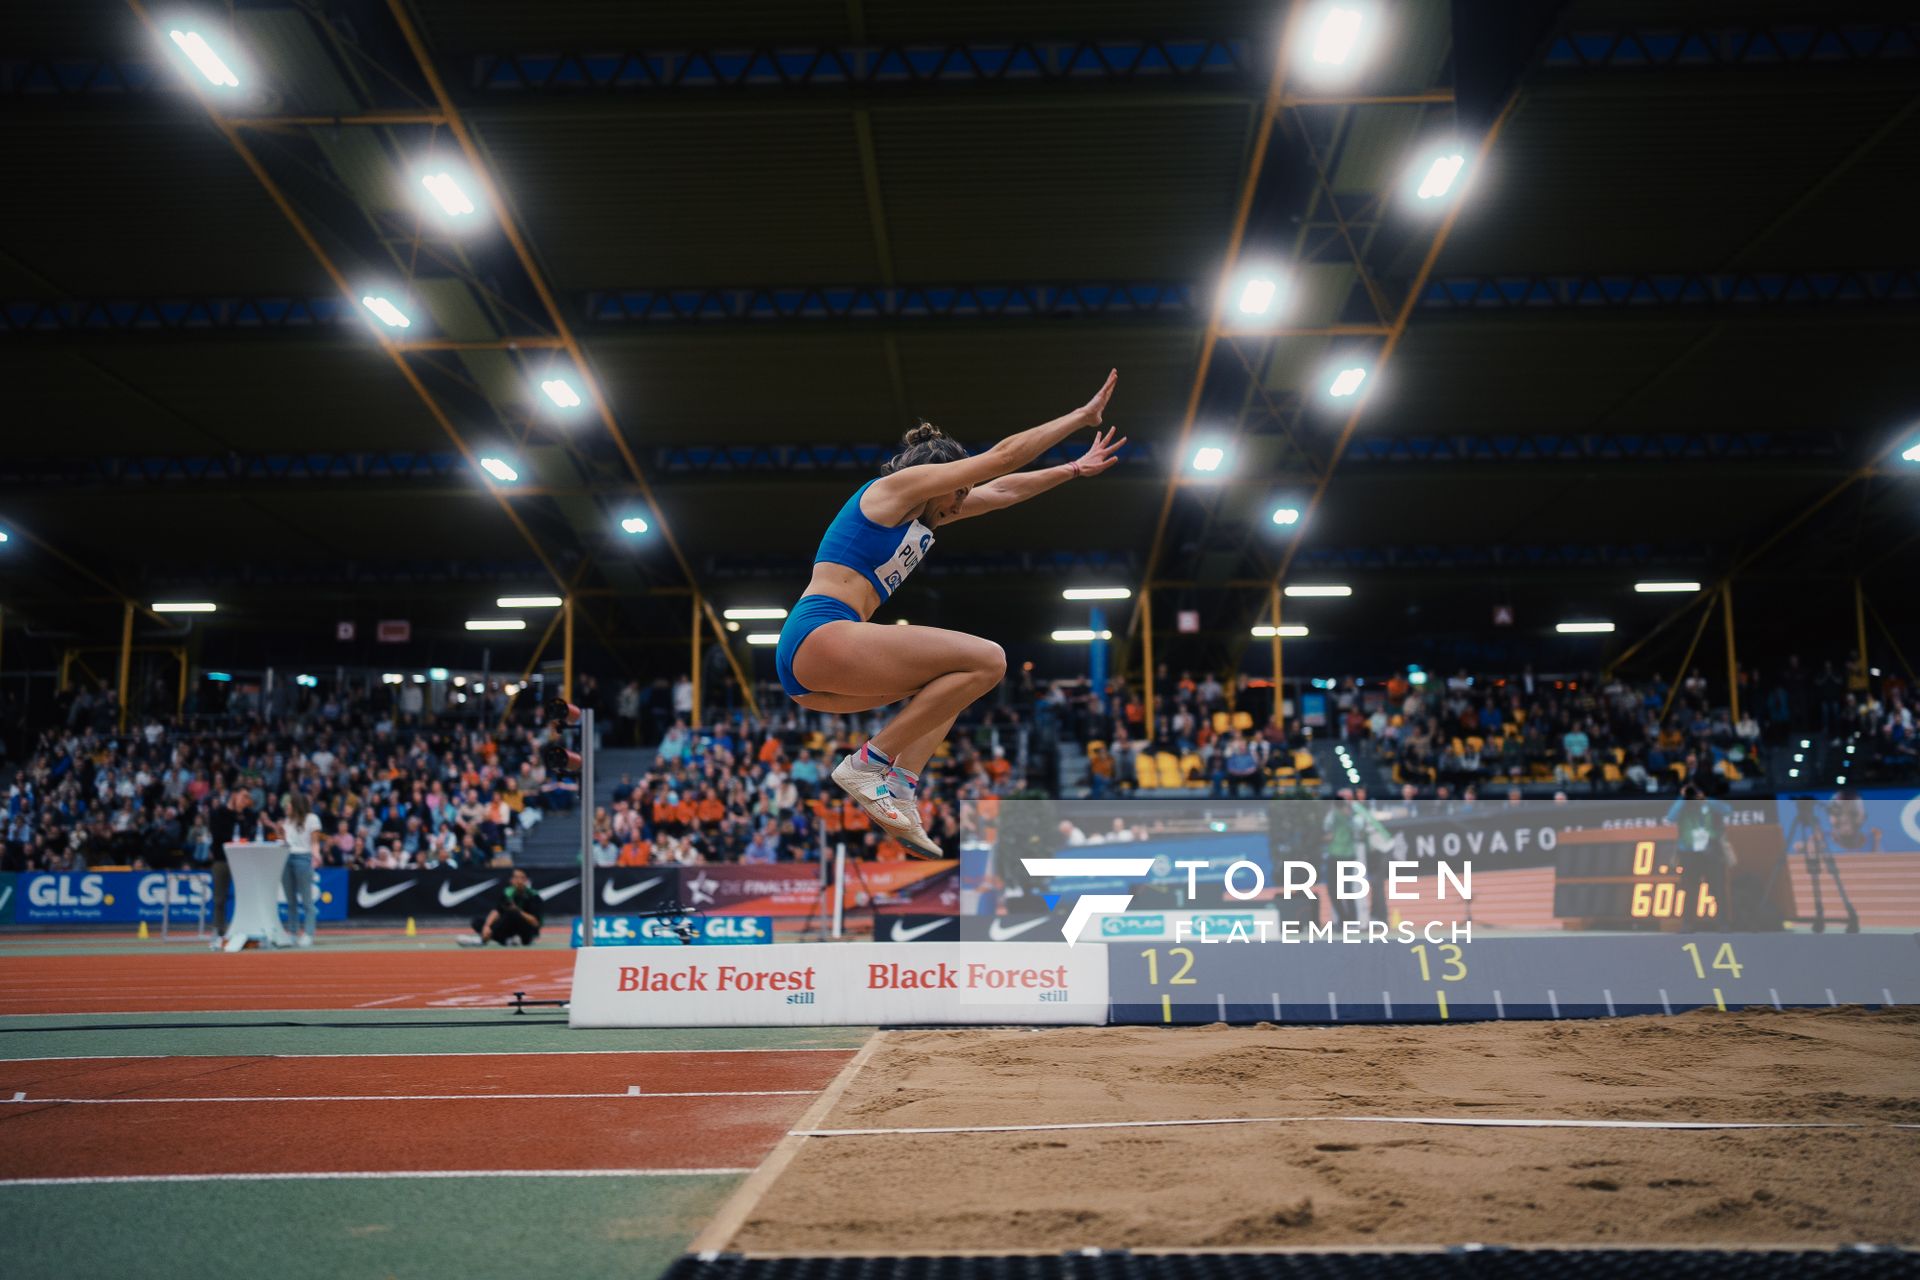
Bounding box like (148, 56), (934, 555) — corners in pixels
(774, 370), (1127, 858)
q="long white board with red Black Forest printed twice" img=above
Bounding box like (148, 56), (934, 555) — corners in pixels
(568, 942), (1108, 1027)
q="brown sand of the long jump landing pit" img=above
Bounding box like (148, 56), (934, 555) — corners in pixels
(733, 1009), (1920, 1251)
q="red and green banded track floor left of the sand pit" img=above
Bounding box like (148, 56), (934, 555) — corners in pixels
(0, 938), (868, 1280)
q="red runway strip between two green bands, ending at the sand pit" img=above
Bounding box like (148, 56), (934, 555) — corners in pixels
(0, 1050), (852, 1178)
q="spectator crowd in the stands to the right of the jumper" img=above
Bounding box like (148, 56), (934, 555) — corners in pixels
(1037, 658), (1920, 798)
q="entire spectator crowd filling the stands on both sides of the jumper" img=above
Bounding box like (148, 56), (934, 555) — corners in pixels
(0, 658), (1920, 871)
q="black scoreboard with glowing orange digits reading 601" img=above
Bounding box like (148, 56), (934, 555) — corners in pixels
(1553, 827), (1726, 929)
